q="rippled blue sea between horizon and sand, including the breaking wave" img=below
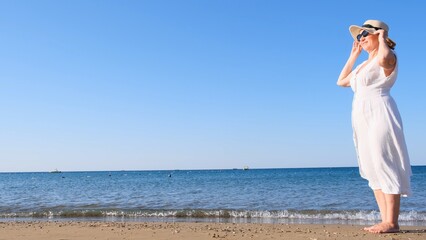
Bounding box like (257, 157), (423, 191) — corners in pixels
(0, 166), (426, 226)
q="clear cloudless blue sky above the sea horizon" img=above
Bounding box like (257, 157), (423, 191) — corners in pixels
(0, 0), (426, 172)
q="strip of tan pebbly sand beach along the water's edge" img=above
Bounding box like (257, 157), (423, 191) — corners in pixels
(0, 221), (426, 240)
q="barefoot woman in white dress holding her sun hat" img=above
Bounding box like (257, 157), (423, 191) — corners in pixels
(337, 20), (411, 233)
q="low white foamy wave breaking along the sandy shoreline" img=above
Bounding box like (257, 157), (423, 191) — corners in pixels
(0, 209), (426, 225)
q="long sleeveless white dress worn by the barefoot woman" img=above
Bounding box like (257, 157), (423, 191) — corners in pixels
(350, 55), (412, 196)
